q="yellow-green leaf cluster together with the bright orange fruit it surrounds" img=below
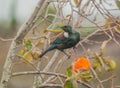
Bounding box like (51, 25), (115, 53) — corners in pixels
(65, 40), (116, 88)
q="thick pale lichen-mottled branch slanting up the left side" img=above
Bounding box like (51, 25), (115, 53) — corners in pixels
(0, 0), (47, 88)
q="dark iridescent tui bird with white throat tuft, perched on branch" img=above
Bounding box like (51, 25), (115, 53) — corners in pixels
(39, 25), (80, 58)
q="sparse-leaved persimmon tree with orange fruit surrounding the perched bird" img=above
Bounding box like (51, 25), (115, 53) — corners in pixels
(0, 0), (120, 88)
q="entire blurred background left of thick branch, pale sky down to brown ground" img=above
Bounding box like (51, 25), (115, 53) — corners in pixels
(0, 0), (38, 88)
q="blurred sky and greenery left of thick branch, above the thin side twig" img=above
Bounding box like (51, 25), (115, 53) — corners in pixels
(0, 0), (38, 38)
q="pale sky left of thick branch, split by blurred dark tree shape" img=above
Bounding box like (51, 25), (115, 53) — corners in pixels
(0, 0), (38, 20)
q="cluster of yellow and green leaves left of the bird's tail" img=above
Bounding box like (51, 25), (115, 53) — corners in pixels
(19, 39), (43, 64)
